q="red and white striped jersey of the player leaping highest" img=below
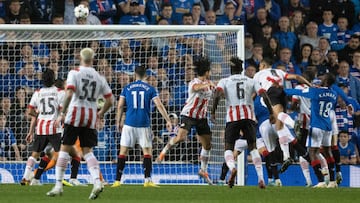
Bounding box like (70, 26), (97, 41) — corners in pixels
(254, 68), (287, 92)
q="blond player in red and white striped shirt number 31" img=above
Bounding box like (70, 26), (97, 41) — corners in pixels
(47, 48), (113, 199)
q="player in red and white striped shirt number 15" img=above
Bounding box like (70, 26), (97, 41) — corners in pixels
(21, 69), (64, 185)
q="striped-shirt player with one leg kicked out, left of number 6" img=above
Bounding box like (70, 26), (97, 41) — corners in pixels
(157, 58), (215, 184)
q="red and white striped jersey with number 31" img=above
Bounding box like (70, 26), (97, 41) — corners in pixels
(65, 66), (112, 129)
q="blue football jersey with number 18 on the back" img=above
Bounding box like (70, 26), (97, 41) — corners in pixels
(285, 87), (337, 131)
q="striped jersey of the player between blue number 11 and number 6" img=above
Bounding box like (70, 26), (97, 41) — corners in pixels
(181, 78), (213, 119)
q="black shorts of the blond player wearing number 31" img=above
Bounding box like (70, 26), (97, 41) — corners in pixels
(63, 124), (97, 147)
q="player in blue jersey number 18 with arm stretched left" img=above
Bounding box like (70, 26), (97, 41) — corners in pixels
(285, 73), (337, 187)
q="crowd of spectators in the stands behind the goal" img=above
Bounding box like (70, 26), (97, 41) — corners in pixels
(0, 0), (360, 163)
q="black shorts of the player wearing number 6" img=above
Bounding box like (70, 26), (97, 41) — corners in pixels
(225, 119), (256, 145)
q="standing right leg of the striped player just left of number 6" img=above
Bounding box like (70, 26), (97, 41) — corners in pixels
(198, 135), (214, 185)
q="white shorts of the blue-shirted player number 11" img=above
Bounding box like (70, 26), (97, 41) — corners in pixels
(120, 125), (152, 148)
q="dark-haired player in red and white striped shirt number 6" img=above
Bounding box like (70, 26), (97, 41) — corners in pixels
(211, 57), (265, 188)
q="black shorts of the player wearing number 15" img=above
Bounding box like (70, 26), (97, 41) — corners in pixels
(33, 133), (61, 152)
